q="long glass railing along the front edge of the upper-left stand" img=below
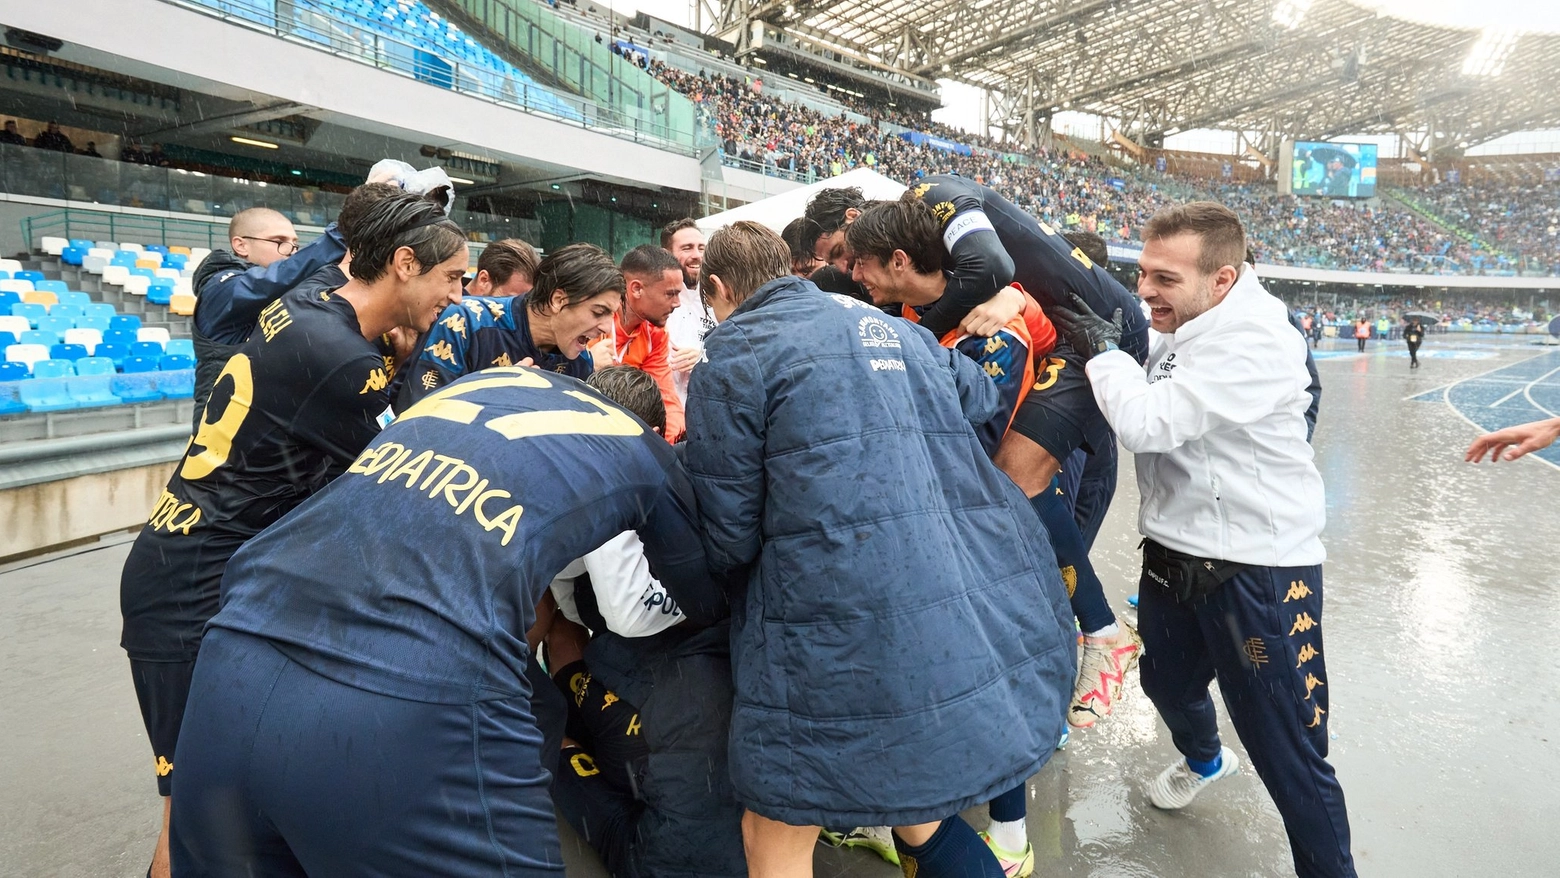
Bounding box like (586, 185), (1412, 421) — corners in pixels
(165, 0), (699, 156)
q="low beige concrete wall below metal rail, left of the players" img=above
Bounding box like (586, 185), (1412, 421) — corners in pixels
(0, 462), (175, 561)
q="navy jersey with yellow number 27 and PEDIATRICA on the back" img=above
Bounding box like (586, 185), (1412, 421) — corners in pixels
(211, 366), (725, 703)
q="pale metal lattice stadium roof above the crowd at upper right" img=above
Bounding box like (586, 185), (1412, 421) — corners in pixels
(707, 0), (1560, 153)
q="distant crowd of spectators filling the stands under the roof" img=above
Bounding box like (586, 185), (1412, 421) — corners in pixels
(647, 61), (1560, 274)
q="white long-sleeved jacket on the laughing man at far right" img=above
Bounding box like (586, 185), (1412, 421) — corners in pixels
(1087, 267), (1326, 568)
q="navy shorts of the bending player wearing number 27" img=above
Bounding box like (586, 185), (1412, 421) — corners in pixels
(172, 628), (563, 878)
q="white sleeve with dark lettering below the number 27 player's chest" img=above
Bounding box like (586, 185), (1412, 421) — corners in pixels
(552, 530), (683, 638)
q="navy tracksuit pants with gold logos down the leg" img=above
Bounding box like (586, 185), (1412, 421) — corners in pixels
(1137, 565), (1354, 878)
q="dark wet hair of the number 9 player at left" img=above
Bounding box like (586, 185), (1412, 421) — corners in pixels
(337, 192), (466, 284)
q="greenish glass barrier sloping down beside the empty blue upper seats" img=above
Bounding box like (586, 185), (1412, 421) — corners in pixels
(446, 0), (705, 147)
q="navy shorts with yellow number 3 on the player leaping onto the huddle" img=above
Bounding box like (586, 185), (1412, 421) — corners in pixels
(1009, 340), (1114, 463)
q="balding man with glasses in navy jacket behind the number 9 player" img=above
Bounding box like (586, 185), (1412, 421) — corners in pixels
(192, 207), (346, 432)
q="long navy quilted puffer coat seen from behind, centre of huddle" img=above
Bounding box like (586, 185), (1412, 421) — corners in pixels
(686, 278), (1076, 827)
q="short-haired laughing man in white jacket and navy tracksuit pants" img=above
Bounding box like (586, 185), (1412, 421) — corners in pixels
(1050, 201), (1356, 878)
